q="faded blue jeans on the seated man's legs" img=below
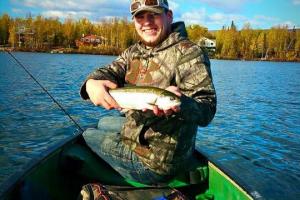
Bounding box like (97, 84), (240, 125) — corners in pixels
(83, 116), (170, 184)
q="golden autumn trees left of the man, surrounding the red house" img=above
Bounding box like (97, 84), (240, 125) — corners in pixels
(0, 14), (137, 54)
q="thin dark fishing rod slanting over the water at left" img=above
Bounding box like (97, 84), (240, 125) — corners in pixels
(5, 50), (84, 132)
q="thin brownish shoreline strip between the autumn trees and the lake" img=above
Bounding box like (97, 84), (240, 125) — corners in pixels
(0, 47), (300, 63)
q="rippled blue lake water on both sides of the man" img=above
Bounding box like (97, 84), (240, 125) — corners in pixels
(0, 53), (300, 200)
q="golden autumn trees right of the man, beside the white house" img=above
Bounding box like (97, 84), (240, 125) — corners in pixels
(187, 21), (300, 61)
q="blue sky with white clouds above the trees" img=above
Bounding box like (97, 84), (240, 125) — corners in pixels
(0, 0), (300, 30)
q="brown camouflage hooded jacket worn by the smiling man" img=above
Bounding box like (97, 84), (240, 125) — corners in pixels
(81, 22), (216, 175)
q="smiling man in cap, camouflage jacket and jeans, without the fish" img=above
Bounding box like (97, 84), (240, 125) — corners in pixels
(81, 0), (216, 184)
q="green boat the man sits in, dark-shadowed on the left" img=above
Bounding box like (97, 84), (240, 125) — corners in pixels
(0, 135), (256, 200)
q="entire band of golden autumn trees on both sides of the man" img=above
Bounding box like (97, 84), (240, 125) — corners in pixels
(0, 14), (300, 61)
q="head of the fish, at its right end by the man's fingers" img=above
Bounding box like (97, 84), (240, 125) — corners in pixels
(155, 93), (181, 110)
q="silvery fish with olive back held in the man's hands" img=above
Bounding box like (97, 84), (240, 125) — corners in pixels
(109, 86), (181, 111)
